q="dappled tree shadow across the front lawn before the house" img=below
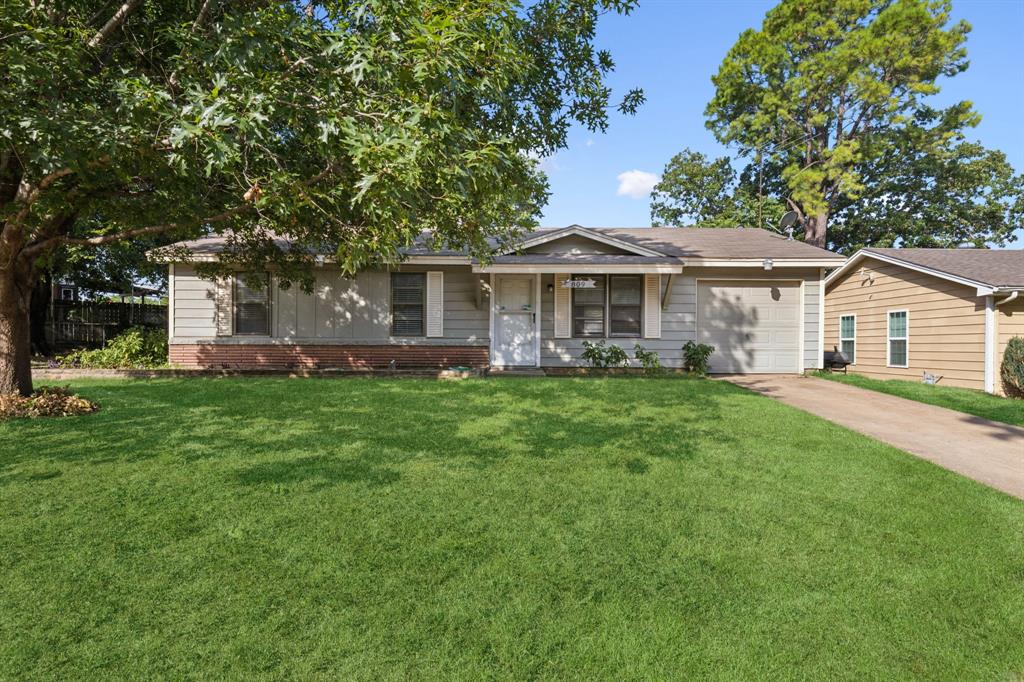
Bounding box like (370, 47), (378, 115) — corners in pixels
(0, 378), (742, 488)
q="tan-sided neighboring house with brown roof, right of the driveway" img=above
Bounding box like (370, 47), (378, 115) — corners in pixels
(825, 249), (1024, 392)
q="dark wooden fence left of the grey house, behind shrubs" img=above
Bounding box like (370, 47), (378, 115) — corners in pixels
(46, 301), (167, 348)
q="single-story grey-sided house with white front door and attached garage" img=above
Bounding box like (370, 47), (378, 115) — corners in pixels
(149, 225), (844, 373)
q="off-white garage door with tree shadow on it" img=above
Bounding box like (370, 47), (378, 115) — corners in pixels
(696, 281), (801, 373)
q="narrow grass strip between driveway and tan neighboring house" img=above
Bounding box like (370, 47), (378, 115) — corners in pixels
(816, 372), (1024, 426)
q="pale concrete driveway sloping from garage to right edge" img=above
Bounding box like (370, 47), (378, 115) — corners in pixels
(720, 375), (1024, 499)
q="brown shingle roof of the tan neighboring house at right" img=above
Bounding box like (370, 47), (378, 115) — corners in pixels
(864, 249), (1024, 289)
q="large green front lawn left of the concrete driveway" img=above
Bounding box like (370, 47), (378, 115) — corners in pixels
(0, 378), (1024, 680)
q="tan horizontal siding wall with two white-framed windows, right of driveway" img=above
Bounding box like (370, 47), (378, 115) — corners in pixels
(825, 259), (985, 389)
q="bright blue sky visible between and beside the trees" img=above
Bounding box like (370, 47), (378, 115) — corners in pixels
(541, 0), (1024, 242)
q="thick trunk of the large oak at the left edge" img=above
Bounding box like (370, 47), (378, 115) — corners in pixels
(0, 267), (32, 395)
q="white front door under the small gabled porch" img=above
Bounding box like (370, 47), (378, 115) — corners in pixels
(493, 274), (537, 367)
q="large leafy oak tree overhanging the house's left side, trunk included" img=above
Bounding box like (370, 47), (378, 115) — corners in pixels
(0, 0), (642, 393)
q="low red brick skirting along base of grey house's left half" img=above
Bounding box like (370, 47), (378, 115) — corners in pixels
(168, 343), (489, 370)
